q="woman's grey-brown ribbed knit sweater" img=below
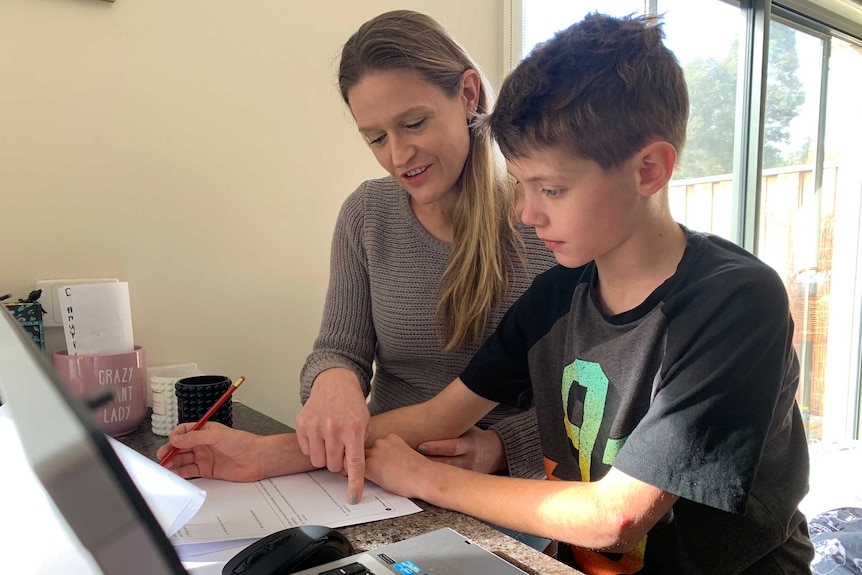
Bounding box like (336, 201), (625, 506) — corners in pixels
(301, 177), (556, 478)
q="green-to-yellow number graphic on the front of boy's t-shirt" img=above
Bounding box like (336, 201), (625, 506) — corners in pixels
(562, 359), (626, 481)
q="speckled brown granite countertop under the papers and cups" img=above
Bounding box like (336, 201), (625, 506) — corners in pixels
(116, 401), (583, 575)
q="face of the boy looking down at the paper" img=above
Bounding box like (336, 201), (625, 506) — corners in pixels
(506, 147), (642, 268)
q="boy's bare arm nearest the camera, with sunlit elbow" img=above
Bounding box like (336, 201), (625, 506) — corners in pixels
(366, 435), (678, 552)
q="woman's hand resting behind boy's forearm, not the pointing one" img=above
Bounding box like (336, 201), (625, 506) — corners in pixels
(418, 427), (507, 473)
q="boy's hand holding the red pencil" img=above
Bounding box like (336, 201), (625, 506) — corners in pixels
(156, 421), (274, 481)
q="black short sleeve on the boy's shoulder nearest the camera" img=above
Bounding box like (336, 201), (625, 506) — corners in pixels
(614, 265), (798, 513)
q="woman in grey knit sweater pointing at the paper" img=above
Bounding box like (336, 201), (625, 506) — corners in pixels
(296, 10), (555, 508)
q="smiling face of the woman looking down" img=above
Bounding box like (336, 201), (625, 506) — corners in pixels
(347, 70), (480, 205)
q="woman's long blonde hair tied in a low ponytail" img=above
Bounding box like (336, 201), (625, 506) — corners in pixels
(338, 10), (523, 351)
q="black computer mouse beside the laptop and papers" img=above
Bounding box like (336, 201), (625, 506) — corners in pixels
(222, 525), (354, 575)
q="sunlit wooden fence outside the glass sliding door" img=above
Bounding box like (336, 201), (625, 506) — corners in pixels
(669, 165), (838, 440)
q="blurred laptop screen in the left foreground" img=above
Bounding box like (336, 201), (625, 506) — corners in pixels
(0, 312), (187, 575)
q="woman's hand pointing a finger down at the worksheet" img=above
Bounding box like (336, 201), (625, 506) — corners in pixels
(296, 368), (371, 504)
